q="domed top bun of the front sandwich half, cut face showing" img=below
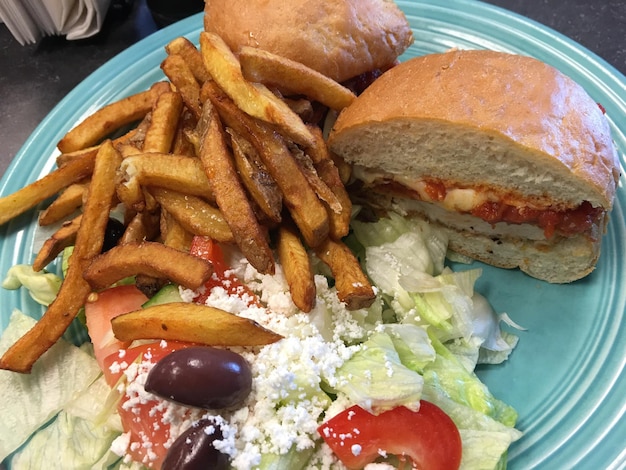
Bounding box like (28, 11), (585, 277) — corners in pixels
(329, 50), (619, 209)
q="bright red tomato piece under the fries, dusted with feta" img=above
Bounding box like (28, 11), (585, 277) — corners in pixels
(189, 235), (261, 306)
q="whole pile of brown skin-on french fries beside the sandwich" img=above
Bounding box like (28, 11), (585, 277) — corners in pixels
(0, 32), (375, 372)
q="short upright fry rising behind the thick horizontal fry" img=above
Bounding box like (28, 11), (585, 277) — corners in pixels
(142, 91), (183, 153)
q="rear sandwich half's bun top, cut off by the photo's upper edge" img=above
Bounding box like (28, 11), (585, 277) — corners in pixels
(204, 0), (413, 82)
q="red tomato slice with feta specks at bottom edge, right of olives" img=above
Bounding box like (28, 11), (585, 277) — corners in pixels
(318, 400), (461, 470)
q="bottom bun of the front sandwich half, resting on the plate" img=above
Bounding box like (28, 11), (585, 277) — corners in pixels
(375, 196), (606, 284)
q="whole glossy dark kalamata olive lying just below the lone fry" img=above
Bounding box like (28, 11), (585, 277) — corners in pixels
(144, 346), (252, 409)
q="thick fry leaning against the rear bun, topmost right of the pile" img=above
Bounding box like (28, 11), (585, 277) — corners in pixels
(239, 46), (356, 111)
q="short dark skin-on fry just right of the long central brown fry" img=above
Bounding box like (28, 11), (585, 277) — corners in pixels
(226, 129), (283, 223)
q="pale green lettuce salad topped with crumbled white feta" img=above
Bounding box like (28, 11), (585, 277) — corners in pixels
(0, 214), (521, 470)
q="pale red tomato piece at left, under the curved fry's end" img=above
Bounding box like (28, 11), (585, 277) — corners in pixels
(85, 285), (148, 374)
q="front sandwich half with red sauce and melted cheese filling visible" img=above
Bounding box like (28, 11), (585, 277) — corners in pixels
(328, 50), (619, 283)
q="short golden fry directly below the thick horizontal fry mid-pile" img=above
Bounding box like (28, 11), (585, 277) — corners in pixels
(150, 187), (235, 243)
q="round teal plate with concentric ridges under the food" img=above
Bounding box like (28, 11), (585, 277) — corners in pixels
(0, 0), (626, 470)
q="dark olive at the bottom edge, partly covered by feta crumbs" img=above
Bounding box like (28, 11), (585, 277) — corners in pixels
(161, 419), (230, 470)
